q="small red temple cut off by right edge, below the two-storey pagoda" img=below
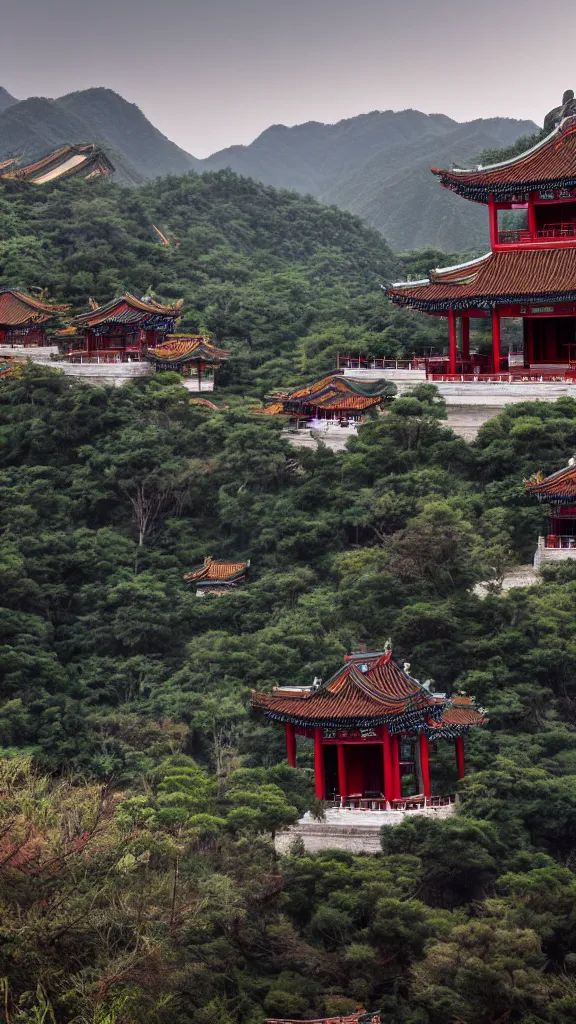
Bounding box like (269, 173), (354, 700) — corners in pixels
(526, 458), (576, 568)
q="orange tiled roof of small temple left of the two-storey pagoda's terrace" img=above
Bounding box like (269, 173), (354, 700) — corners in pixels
(254, 374), (389, 416)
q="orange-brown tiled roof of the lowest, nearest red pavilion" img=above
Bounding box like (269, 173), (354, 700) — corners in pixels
(252, 650), (484, 735)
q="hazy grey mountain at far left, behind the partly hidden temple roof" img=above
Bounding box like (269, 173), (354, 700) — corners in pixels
(0, 89), (196, 184)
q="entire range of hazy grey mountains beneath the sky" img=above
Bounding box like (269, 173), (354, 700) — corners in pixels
(0, 88), (536, 251)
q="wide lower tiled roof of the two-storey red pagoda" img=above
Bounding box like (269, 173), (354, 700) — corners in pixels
(387, 248), (576, 313)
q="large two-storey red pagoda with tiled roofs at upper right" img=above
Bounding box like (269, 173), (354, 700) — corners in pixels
(387, 116), (576, 380)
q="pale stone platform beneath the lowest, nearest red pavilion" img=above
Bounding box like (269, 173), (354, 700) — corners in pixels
(275, 804), (456, 853)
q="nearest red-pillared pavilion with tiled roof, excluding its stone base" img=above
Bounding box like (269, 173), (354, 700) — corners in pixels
(252, 650), (485, 808)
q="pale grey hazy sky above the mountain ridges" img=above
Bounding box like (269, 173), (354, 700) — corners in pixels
(0, 0), (576, 157)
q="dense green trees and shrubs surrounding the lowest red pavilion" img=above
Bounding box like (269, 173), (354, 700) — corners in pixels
(0, 367), (576, 1024)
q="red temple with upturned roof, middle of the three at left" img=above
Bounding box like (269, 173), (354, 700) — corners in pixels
(56, 293), (180, 364)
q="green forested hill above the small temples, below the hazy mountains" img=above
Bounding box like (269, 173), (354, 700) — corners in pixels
(0, 171), (452, 385)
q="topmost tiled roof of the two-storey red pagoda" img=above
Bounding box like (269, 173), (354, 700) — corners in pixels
(431, 117), (576, 203)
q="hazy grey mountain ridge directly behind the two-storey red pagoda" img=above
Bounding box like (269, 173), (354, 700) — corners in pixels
(202, 111), (536, 251)
